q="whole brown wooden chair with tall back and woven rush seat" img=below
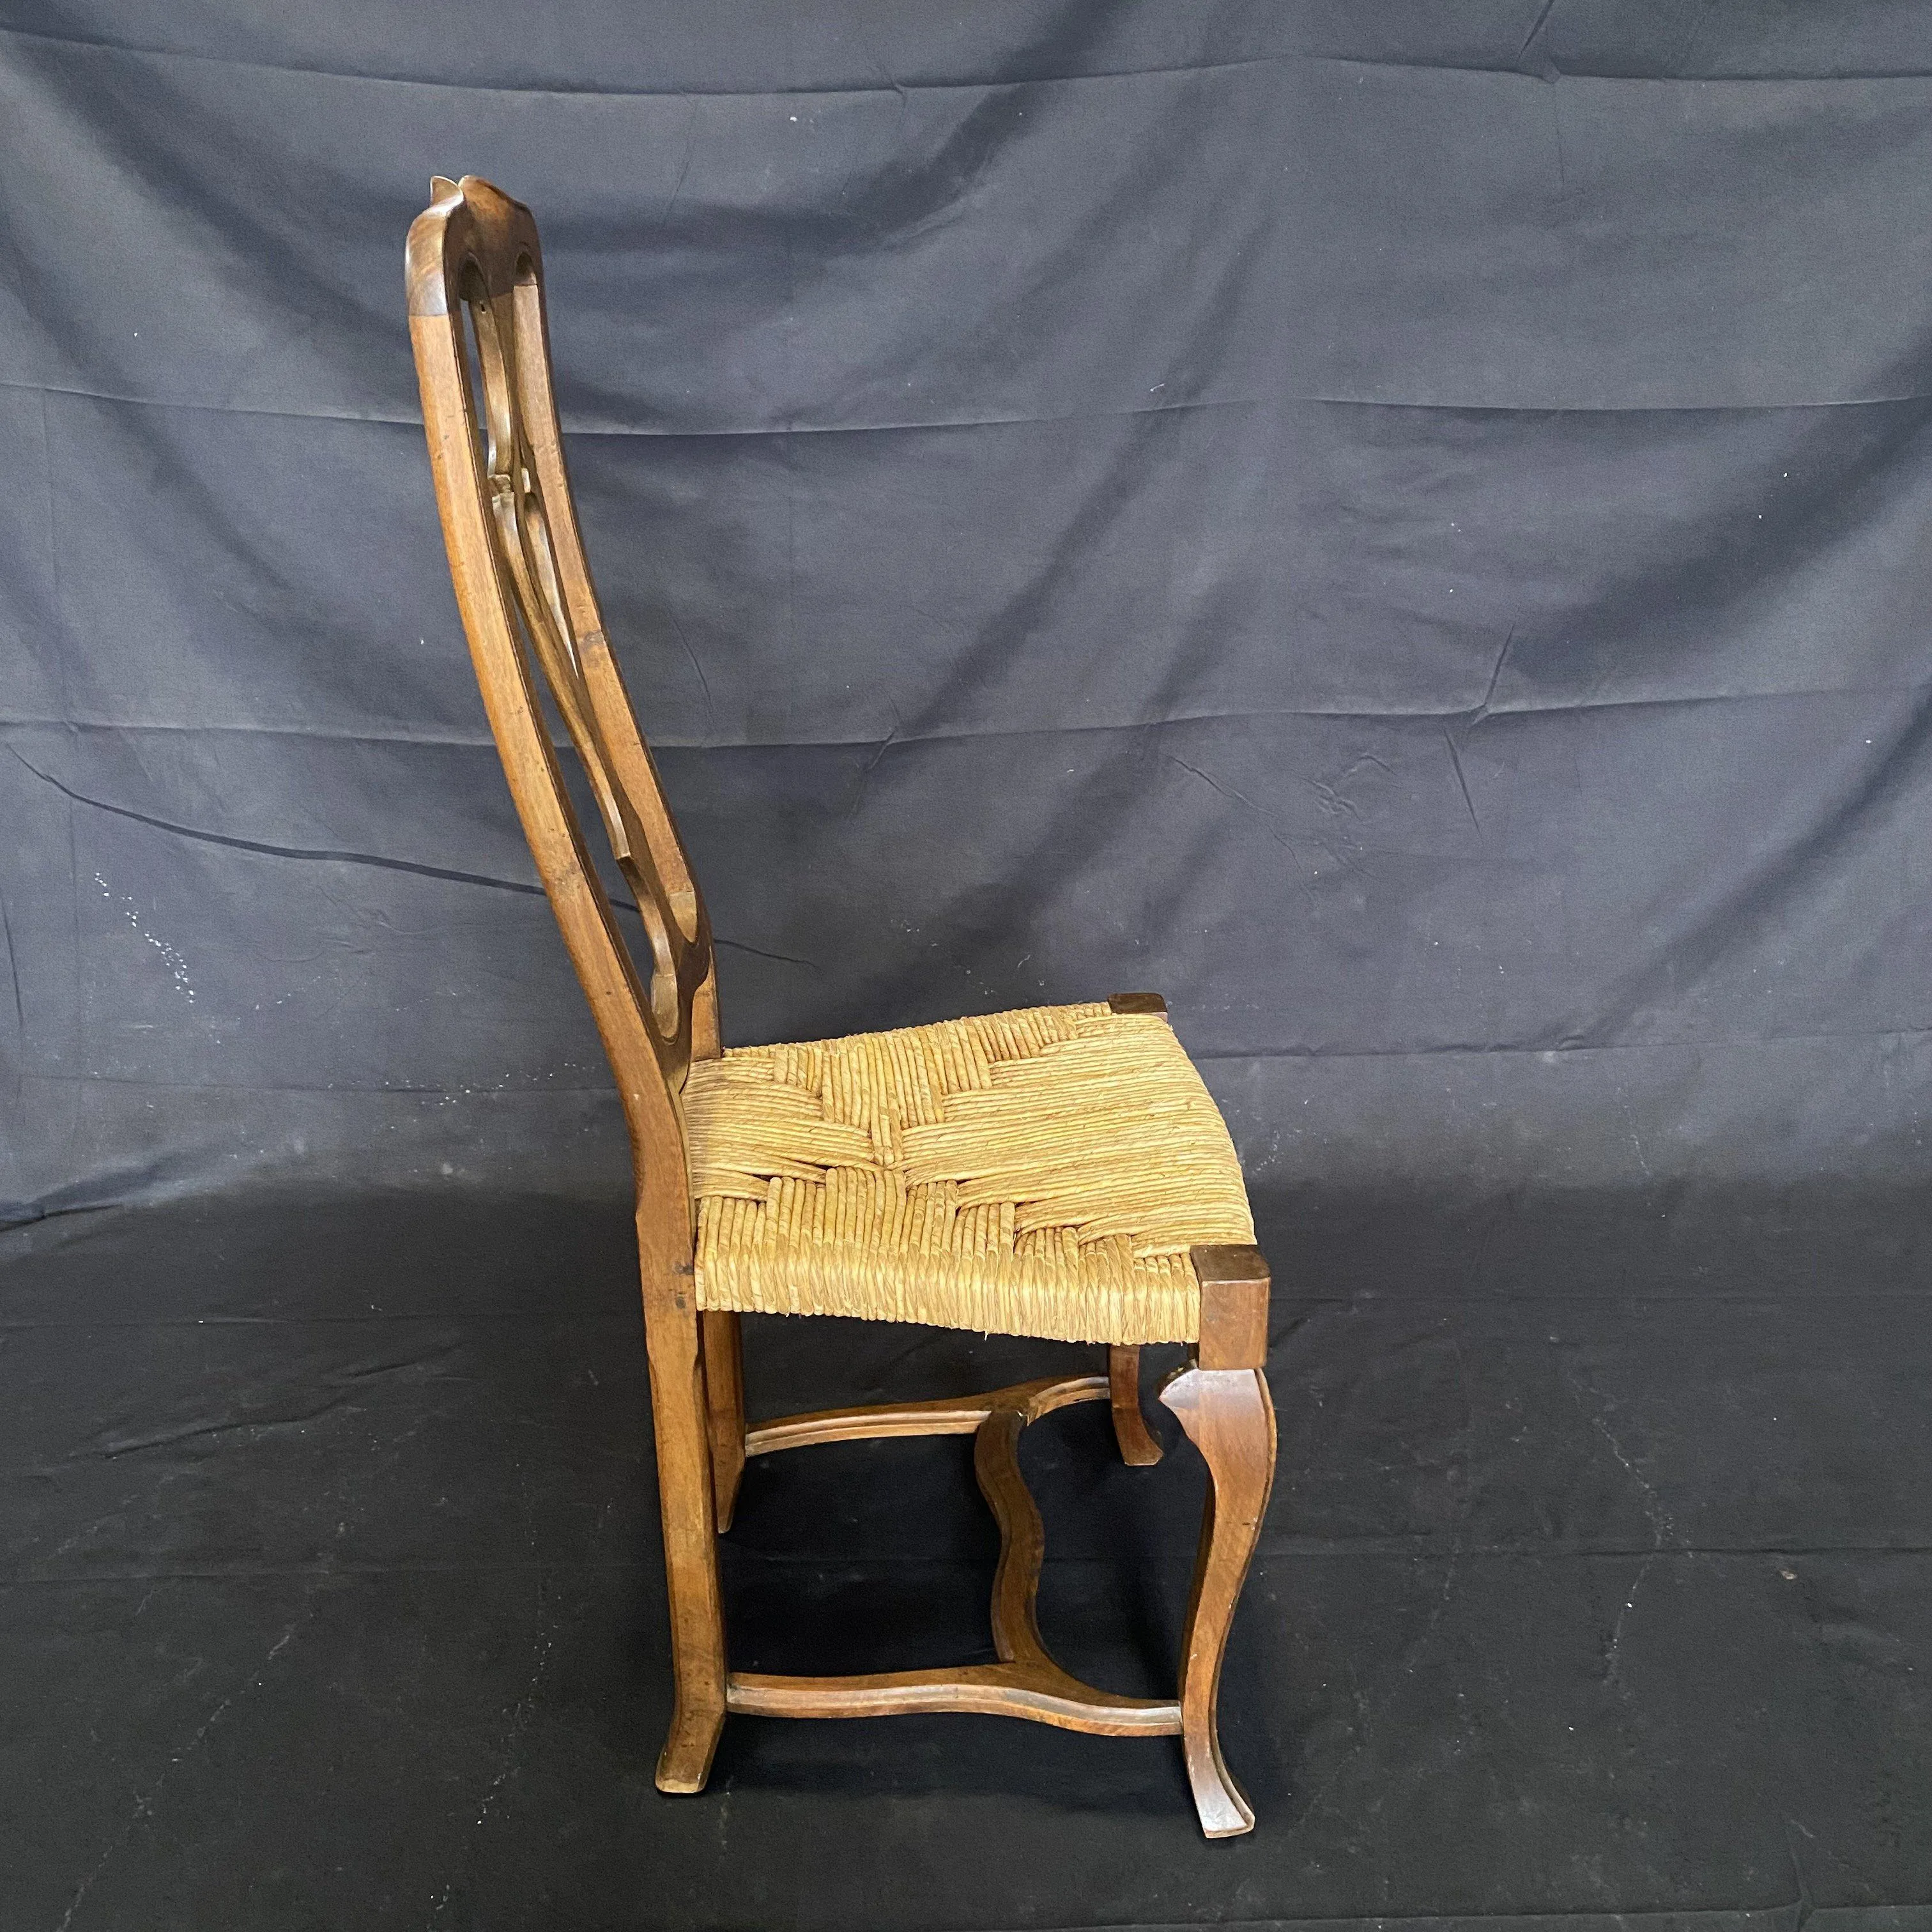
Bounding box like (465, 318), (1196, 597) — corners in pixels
(408, 176), (1275, 1837)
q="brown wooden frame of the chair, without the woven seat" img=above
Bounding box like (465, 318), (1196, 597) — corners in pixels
(408, 176), (1275, 1837)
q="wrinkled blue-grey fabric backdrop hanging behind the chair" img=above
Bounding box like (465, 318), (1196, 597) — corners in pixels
(0, 0), (1932, 1219)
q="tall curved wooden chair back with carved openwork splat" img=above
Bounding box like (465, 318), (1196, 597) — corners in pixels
(408, 176), (719, 1174)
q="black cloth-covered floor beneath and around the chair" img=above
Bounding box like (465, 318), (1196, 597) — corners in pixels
(0, 1192), (1932, 1932)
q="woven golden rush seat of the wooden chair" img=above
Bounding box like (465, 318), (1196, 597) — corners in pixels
(684, 1004), (1254, 1343)
